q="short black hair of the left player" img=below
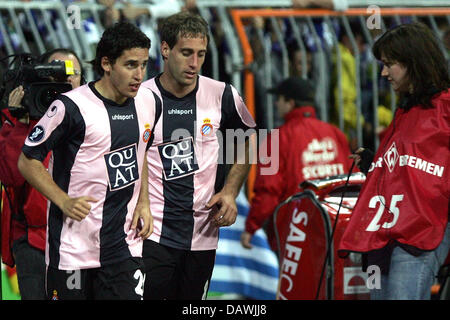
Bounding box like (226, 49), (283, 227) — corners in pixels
(92, 22), (150, 76)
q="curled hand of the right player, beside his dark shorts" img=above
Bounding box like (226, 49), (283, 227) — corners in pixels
(206, 191), (237, 227)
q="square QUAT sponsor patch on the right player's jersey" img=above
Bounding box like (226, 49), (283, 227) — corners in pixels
(158, 137), (198, 180)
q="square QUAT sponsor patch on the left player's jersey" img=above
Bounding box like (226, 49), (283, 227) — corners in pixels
(104, 144), (139, 191)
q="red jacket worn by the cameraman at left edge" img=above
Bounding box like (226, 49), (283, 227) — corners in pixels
(0, 112), (49, 266)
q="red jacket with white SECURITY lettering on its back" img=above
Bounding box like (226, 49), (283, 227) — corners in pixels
(245, 107), (351, 250)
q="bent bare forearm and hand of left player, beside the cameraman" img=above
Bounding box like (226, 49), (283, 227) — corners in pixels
(17, 152), (97, 221)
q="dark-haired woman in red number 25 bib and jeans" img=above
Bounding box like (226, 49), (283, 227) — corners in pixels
(338, 23), (450, 300)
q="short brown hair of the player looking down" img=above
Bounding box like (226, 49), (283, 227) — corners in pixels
(160, 11), (210, 49)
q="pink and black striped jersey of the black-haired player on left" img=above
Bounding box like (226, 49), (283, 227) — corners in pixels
(22, 82), (161, 270)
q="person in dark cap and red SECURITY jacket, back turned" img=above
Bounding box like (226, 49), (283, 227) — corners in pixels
(241, 77), (352, 251)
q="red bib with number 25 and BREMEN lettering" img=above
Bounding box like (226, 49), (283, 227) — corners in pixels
(338, 90), (450, 255)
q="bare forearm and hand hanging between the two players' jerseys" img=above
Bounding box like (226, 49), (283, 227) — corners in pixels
(131, 157), (153, 240)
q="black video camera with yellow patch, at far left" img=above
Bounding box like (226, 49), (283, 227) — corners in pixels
(1, 54), (74, 119)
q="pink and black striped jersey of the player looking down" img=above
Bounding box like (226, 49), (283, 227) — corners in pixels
(142, 76), (256, 250)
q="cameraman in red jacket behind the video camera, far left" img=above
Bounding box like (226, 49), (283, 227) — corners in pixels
(0, 48), (82, 300)
